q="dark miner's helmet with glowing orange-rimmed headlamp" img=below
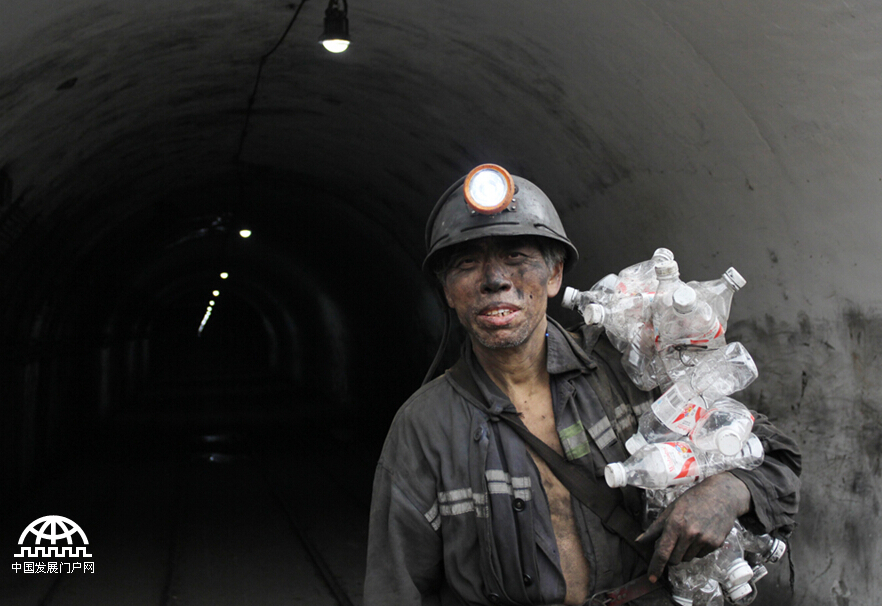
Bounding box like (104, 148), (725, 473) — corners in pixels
(423, 164), (579, 272)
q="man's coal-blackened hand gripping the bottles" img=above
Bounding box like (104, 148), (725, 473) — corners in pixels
(637, 472), (750, 583)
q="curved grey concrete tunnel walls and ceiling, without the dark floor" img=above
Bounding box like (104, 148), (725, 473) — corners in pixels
(0, 0), (882, 606)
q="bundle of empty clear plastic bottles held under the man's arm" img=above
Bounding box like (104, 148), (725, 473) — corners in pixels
(563, 248), (784, 606)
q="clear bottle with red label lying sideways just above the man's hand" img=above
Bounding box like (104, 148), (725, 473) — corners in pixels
(604, 436), (763, 488)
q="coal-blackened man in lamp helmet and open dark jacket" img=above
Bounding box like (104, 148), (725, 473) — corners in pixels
(365, 165), (800, 606)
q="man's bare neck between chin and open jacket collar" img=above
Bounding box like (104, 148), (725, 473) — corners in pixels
(472, 320), (548, 406)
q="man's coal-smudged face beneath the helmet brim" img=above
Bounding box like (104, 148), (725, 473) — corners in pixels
(443, 237), (563, 349)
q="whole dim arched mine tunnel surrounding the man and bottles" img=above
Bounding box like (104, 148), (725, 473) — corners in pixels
(0, 0), (882, 606)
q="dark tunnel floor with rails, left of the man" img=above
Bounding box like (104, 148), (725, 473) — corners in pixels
(0, 404), (378, 606)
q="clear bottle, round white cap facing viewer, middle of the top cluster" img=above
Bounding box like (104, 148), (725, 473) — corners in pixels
(653, 284), (726, 351)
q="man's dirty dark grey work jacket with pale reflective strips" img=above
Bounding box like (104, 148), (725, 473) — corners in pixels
(364, 318), (799, 606)
